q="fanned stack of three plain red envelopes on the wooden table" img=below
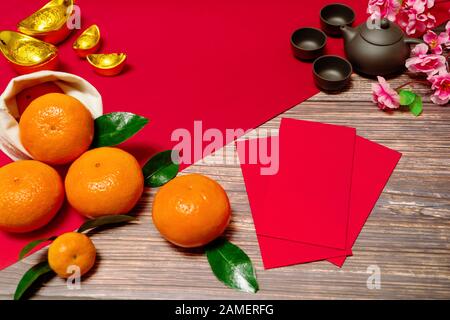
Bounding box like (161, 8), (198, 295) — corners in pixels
(237, 119), (401, 269)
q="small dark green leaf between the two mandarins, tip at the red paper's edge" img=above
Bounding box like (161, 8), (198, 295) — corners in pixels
(142, 150), (180, 188)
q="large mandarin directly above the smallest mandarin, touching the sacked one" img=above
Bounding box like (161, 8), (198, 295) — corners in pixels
(65, 147), (144, 218)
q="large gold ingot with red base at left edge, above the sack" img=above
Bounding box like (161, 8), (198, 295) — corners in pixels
(0, 31), (58, 74)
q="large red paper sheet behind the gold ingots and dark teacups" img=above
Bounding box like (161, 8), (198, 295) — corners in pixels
(0, 0), (366, 168)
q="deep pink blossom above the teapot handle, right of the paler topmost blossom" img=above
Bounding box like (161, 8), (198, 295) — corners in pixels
(397, 7), (436, 36)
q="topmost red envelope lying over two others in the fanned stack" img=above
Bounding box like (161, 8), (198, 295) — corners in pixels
(259, 119), (356, 249)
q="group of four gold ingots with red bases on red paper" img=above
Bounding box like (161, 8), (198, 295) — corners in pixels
(0, 0), (127, 76)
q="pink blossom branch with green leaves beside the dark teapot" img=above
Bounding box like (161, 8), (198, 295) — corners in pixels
(367, 0), (450, 116)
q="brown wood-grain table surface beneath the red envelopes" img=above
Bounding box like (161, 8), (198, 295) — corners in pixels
(0, 75), (450, 299)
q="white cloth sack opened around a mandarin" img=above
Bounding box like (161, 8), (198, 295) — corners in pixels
(0, 71), (103, 161)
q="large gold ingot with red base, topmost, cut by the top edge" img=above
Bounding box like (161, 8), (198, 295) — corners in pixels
(17, 0), (73, 44)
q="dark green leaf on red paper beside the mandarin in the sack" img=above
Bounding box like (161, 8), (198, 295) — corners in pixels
(92, 112), (149, 148)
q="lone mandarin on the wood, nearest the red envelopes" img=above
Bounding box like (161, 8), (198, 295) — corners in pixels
(153, 174), (231, 248)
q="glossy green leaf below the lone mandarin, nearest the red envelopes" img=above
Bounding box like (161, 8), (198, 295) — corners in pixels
(206, 239), (259, 293)
